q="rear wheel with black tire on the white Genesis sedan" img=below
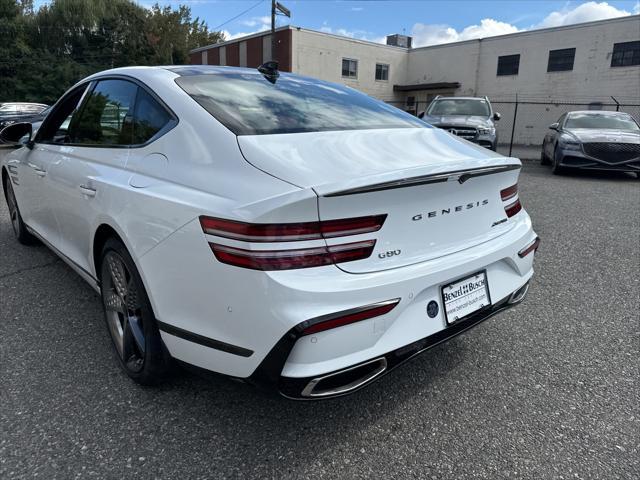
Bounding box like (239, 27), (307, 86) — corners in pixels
(100, 238), (172, 385)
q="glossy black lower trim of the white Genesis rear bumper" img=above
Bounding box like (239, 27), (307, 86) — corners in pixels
(247, 297), (513, 400)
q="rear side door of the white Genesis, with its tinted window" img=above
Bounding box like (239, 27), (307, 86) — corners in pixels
(49, 78), (138, 272)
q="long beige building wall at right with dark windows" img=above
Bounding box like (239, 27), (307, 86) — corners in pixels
(406, 15), (640, 103)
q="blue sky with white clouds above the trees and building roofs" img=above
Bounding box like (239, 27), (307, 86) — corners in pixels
(166, 0), (640, 46)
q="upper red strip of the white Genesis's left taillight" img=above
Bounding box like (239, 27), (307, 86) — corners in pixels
(200, 214), (387, 242)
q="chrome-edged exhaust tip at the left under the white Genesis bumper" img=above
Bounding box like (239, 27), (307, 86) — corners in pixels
(300, 357), (387, 398)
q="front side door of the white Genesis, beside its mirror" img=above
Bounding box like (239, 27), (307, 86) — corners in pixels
(16, 85), (87, 248)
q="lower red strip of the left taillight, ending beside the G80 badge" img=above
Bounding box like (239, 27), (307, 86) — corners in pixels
(209, 240), (376, 270)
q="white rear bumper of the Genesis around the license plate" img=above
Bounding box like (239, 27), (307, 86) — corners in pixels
(140, 210), (536, 385)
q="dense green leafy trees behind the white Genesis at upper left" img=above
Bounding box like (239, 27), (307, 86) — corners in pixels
(0, 0), (223, 103)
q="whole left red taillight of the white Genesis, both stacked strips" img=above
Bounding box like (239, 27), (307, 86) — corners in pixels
(200, 214), (387, 270)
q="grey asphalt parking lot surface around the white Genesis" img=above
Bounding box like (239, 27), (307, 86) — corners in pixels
(0, 163), (640, 479)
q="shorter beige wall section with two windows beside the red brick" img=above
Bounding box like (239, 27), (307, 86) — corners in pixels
(292, 29), (407, 100)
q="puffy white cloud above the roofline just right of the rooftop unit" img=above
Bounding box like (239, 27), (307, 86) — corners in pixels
(411, 18), (519, 47)
